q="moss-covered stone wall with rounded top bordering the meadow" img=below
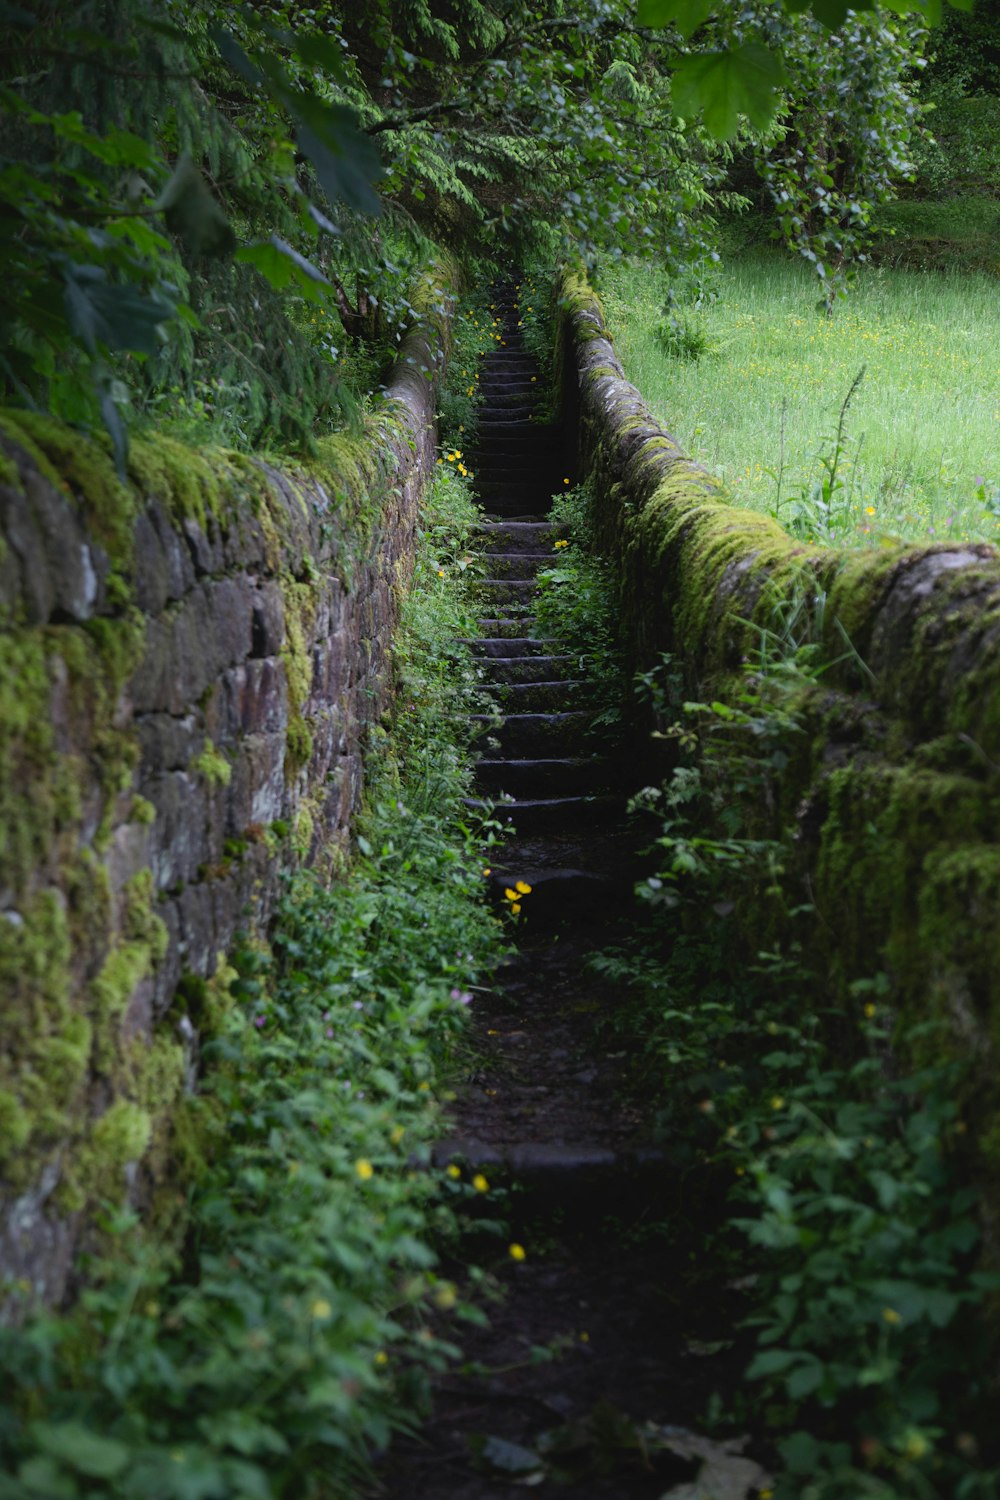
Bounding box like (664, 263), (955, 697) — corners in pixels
(562, 278), (1000, 1200)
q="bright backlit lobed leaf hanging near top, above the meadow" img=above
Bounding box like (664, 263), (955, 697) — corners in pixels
(672, 42), (784, 141)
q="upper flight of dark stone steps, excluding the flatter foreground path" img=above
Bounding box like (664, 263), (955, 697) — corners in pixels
(471, 287), (630, 924)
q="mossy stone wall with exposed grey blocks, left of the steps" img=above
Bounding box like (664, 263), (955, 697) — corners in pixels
(0, 261), (450, 1301)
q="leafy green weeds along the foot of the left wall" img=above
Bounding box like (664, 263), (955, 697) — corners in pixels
(0, 479), (501, 1500)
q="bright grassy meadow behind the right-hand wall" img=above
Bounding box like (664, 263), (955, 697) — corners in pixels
(600, 251), (1000, 546)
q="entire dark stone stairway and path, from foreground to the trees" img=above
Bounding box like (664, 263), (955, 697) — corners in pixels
(378, 287), (743, 1500)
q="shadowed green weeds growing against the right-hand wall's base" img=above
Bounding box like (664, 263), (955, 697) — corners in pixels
(597, 641), (1000, 1500)
